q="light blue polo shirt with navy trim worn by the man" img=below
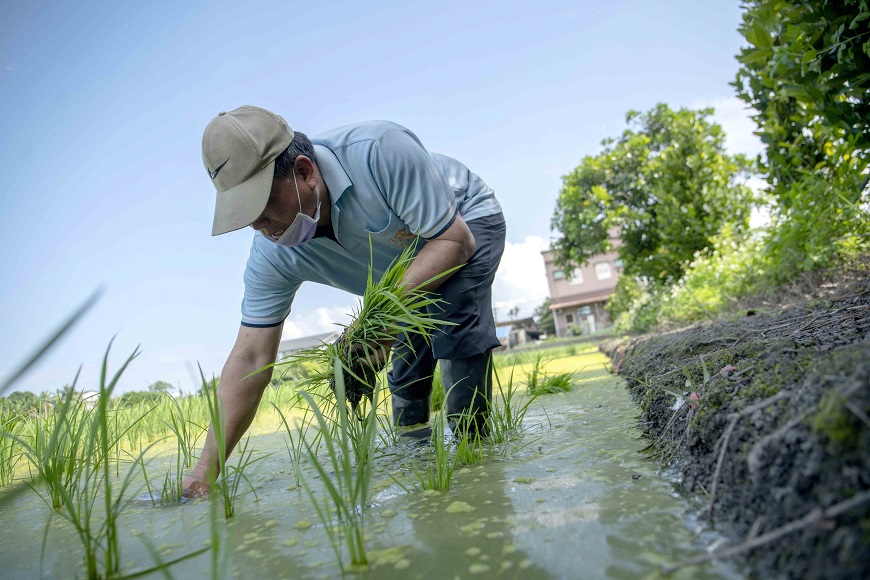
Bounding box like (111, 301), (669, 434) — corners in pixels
(242, 121), (501, 327)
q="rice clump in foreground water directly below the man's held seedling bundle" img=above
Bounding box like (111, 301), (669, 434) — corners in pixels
(301, 358), (379, 570)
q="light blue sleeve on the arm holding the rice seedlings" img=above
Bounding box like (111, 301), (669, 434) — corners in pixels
(371, 128), (457, 239)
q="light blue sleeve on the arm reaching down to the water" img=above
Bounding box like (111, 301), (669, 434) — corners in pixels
(242, 235), (302, 328)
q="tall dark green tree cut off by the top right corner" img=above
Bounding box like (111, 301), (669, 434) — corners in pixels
(735, 0), (870, 282)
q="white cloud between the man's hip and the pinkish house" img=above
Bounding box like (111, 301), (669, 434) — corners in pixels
(492, 236), (550, 320)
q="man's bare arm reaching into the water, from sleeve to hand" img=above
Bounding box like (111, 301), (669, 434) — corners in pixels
(182, 324), (284, 497)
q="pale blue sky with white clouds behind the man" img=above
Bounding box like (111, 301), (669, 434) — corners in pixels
(0, 0), (758, 391)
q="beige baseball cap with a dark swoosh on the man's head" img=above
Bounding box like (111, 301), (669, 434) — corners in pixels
(202, 105), (293, 236)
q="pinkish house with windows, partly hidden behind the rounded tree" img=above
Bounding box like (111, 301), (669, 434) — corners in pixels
(541, 250), (622, 337)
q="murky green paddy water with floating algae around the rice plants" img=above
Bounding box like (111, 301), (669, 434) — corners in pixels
(0, 353), (739, 578)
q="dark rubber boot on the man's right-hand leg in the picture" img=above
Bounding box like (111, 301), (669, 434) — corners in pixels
(439, 351), (492, 437)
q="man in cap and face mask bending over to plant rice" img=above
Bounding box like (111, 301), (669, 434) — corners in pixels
(183, 106), (505, 497)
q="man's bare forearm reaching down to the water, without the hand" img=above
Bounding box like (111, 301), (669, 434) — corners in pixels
(191, 357), (272, 479)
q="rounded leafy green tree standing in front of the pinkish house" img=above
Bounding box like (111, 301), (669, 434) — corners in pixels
(551, 104), (753, 283)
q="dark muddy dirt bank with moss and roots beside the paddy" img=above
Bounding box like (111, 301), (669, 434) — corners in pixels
(604, 274), (870, 578)
